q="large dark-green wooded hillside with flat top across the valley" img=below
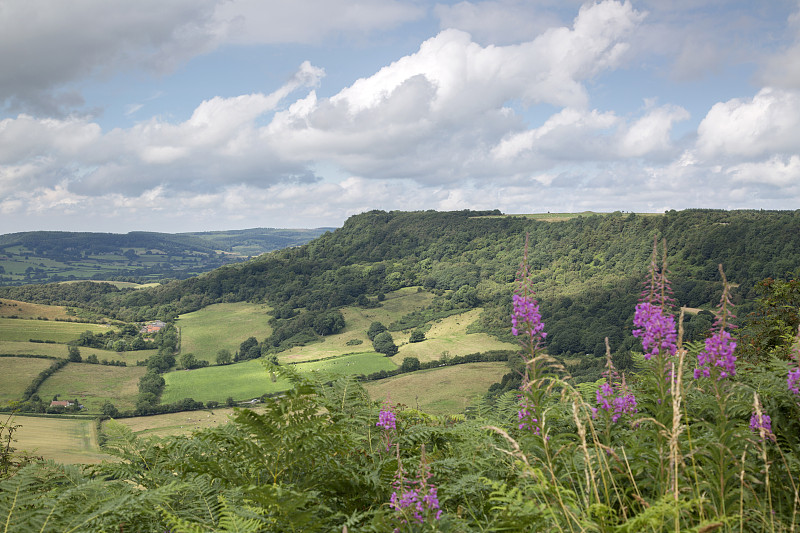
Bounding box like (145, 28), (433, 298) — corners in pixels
(0, 209), (800, 372)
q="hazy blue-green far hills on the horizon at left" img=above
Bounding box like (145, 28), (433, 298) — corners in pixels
(0, 228), (335, 286)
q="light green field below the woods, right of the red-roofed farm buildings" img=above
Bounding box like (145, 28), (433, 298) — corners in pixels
(177, 302), (272, 364)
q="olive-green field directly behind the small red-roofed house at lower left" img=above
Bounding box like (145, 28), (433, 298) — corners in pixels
(38, 363), (147, 413)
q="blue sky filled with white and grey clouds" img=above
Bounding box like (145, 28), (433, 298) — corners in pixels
(0, 0), (800, 234)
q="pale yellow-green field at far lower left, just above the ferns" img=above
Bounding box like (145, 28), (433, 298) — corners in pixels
(13, 416), (113, 464)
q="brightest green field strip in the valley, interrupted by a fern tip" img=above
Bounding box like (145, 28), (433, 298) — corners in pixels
(161, 352), (397, 403)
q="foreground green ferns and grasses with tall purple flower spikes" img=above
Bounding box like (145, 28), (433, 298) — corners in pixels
(0, 239), (800, 532)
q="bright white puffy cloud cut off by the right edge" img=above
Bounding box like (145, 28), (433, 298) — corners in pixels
(697, 87), (800, 158)
